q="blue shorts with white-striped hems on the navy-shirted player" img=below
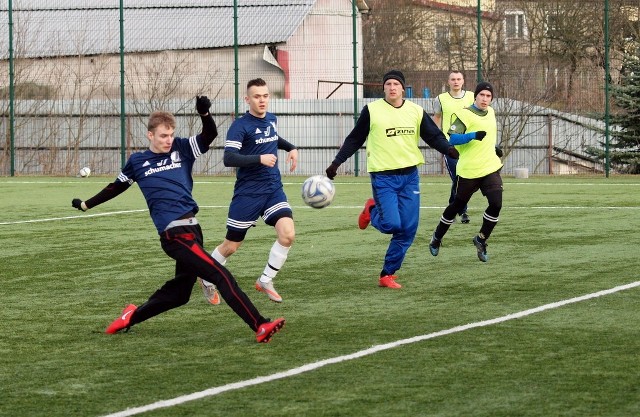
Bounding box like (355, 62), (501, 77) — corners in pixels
(227, 188), (293, 235)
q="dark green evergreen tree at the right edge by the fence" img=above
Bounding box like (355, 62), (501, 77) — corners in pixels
(587, 50), (640, 174)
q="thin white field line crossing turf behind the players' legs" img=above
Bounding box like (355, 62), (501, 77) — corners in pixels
(0, 205), (640, 226)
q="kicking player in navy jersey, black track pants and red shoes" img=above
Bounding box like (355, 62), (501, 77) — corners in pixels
(71, 96), (285, 343)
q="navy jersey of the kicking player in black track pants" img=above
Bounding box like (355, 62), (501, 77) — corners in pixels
(116, 136), (209, 233)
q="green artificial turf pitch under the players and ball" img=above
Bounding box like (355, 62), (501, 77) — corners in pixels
(0, 176), (640, 417)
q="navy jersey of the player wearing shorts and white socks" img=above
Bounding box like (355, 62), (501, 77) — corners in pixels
(224, 112), (282, 194)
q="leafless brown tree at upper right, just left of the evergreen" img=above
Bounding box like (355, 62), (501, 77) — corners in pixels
(496, 0), (632, 113)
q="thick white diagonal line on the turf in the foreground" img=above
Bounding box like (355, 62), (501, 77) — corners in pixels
(104, 281), (640, 417)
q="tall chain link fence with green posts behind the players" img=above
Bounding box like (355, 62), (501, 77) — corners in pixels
(0, 0), (638, 175)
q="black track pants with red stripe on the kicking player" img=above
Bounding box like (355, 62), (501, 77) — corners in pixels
(131, 224), (269, 331)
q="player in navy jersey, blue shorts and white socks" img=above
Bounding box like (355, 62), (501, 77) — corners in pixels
(201, 78), (298, 304)
